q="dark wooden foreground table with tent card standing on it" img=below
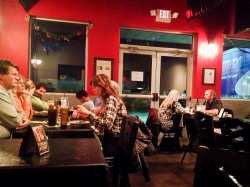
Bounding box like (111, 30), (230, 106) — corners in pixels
(0, 138), (108, 187)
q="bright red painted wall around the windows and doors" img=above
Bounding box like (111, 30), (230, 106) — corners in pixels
(0, 0), (232, 98)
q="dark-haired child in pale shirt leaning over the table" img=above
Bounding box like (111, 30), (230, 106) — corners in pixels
(71, 90), (96, 119)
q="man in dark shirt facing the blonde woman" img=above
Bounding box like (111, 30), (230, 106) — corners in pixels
(204, 90), (223, 116)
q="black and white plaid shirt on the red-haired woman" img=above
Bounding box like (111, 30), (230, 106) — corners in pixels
(88, 96), (127, 136)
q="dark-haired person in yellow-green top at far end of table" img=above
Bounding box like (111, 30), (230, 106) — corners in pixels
(31, 82), (49, 111)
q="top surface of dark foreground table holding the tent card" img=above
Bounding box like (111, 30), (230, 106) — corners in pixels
(0, 138), (106, 170)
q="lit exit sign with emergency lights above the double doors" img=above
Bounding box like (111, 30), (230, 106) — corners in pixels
(150, 9), (179, 23)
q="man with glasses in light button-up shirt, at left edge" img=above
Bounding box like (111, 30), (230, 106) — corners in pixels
(0, 60), (30, 138)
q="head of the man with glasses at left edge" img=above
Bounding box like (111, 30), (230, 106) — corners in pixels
(0, 60), (19, 90)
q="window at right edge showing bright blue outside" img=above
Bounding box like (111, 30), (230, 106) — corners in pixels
(221, 38), (250, 99)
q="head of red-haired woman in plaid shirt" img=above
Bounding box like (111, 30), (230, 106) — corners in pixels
(90, 74), (119, 99)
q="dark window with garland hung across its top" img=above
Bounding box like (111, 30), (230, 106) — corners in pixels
(30, 18), (86, 93)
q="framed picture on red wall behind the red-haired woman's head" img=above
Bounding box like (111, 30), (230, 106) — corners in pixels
(94, 57), (114, 79)
